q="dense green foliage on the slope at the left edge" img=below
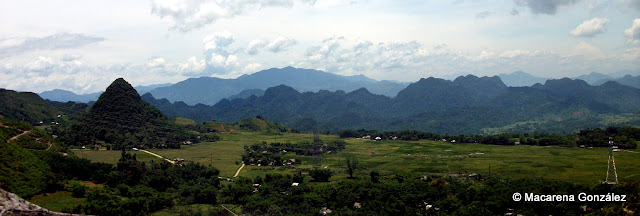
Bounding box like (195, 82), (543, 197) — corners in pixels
(0, 118), (112, 198)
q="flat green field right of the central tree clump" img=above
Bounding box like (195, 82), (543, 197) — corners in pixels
(324, 139), (640, 184)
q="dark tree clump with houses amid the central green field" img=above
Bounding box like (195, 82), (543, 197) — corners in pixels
(242, 139), (346, 166)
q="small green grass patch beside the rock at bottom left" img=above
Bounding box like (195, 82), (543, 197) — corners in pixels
(29, 191), (86, 212)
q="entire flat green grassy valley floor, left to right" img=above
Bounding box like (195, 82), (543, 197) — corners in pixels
(76, 132), (640, 184)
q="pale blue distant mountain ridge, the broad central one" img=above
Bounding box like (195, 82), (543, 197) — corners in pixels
(150, 67), (406, 105)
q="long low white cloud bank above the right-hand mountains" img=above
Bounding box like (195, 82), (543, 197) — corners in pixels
(294, 35), (637, 81)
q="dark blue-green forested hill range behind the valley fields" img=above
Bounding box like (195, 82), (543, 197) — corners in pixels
(143, 75), (640, 134)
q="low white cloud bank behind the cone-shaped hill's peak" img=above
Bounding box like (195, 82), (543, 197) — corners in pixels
(0, 56), (204, 94)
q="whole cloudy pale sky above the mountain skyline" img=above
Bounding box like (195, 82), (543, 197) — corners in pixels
(0, 0), (640, 94)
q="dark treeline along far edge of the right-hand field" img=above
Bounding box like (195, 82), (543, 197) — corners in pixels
(338, 127), (640, 149)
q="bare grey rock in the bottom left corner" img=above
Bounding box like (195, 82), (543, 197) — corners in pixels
(0, 189), (84, 216)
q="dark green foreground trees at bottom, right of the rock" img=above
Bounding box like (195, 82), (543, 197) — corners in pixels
(71, 151), (224, 215)
